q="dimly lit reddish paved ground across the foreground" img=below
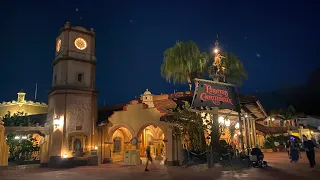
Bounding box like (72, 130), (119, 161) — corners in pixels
(0, 151), (320, 180)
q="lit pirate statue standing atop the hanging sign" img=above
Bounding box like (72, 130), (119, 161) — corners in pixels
(209, 40), (226, 82)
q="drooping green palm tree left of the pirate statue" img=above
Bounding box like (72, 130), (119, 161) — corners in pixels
(160, 41), (208, 91)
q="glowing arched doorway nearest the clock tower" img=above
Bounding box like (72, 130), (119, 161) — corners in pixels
(111, 127), (132, 162)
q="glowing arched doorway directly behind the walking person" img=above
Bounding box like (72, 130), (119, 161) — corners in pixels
(137, 125), (166, 163)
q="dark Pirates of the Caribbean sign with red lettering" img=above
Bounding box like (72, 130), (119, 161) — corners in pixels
(192, 79), (240, 111)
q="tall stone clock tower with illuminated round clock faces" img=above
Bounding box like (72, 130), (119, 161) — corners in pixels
(47, 22), (98, 164)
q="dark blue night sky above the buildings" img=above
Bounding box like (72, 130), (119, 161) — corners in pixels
(0, 0), (320, 104)
